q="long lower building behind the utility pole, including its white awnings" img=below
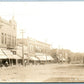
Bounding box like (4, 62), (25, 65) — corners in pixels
(17, 38), (53, 63)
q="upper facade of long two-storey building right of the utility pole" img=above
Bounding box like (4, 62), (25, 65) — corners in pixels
(27, 38), (51, 55)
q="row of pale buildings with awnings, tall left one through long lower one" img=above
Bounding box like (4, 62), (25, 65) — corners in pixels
(0, 17), (53, 64)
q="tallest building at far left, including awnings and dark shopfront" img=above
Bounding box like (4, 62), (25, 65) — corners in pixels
(0, 17), (18, 65)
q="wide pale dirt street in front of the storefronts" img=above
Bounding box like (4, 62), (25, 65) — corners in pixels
(0, 64), (84, 82)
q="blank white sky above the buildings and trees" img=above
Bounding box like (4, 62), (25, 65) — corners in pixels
(0, 1), (84, 52)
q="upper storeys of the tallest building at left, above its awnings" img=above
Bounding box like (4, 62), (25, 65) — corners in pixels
(0, 17), (17, 48)
